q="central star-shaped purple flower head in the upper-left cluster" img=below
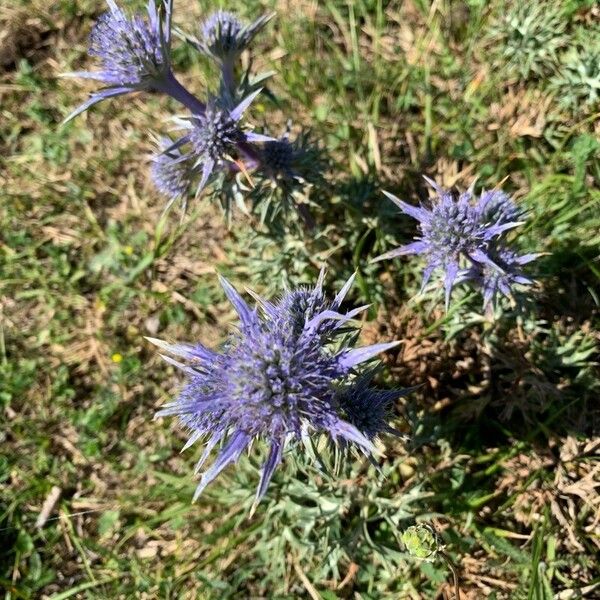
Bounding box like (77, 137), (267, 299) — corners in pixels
(182, 90), (273, 194)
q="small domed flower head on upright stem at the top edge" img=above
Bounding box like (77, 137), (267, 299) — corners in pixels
(195, 10), (273, 64)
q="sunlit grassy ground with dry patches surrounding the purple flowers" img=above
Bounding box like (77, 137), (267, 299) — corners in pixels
(0, 0), (600, 600)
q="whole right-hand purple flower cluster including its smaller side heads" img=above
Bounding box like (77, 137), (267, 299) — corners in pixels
(375, 178), (535, 307)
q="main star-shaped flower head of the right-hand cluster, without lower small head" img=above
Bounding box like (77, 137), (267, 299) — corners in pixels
(375, 177), (521, 308)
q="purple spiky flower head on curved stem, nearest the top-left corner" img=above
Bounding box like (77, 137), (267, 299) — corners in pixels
(66, 0), (173, 121)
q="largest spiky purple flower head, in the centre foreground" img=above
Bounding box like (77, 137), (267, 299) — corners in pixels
(150, 274), (397, 502)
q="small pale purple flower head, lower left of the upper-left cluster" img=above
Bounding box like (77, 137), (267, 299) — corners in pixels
(150, 138), (195, 210)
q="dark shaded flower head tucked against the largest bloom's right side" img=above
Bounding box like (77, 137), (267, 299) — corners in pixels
(338, 371), (410, 440)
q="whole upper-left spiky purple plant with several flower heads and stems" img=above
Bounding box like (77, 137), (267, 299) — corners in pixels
(65, 0), (320, 222)
